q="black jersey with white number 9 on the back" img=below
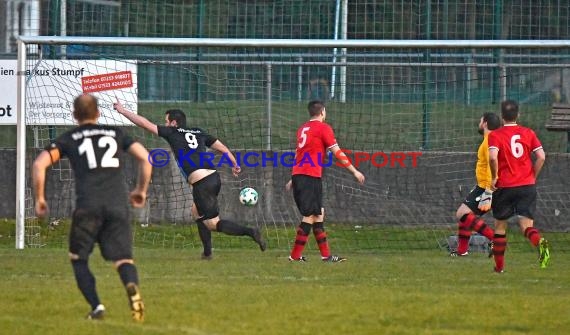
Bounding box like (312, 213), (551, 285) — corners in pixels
(157, 126), (218, 178)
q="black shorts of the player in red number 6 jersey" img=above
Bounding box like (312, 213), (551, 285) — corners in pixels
(492, 185), (536, 220)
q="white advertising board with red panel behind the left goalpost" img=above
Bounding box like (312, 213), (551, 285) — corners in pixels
(0, 60), (137, 125)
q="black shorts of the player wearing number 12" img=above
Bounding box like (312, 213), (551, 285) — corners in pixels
(69, 205), (133, 261)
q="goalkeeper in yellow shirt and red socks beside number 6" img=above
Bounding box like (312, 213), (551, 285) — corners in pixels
(451, 113), (501, 256)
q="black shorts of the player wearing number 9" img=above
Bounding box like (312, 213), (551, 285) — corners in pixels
(192, 172), (222, 220)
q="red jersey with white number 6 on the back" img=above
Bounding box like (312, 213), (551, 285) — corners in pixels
(489, 124), (542, 188)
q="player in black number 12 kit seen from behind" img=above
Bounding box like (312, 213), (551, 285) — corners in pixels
(33, 95), (152, 321)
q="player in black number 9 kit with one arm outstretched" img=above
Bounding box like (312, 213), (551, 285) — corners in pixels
(114, 101), (266, 259)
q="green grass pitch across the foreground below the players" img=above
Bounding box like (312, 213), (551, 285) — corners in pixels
(0, 243), (570, 335)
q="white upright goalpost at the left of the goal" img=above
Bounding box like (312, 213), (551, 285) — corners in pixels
(16, 40), (26, 249)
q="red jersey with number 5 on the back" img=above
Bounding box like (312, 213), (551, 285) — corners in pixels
(293, 120), (337, 178)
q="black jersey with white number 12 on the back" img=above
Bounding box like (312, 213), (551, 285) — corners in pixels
(45, 124), (134, 205)
